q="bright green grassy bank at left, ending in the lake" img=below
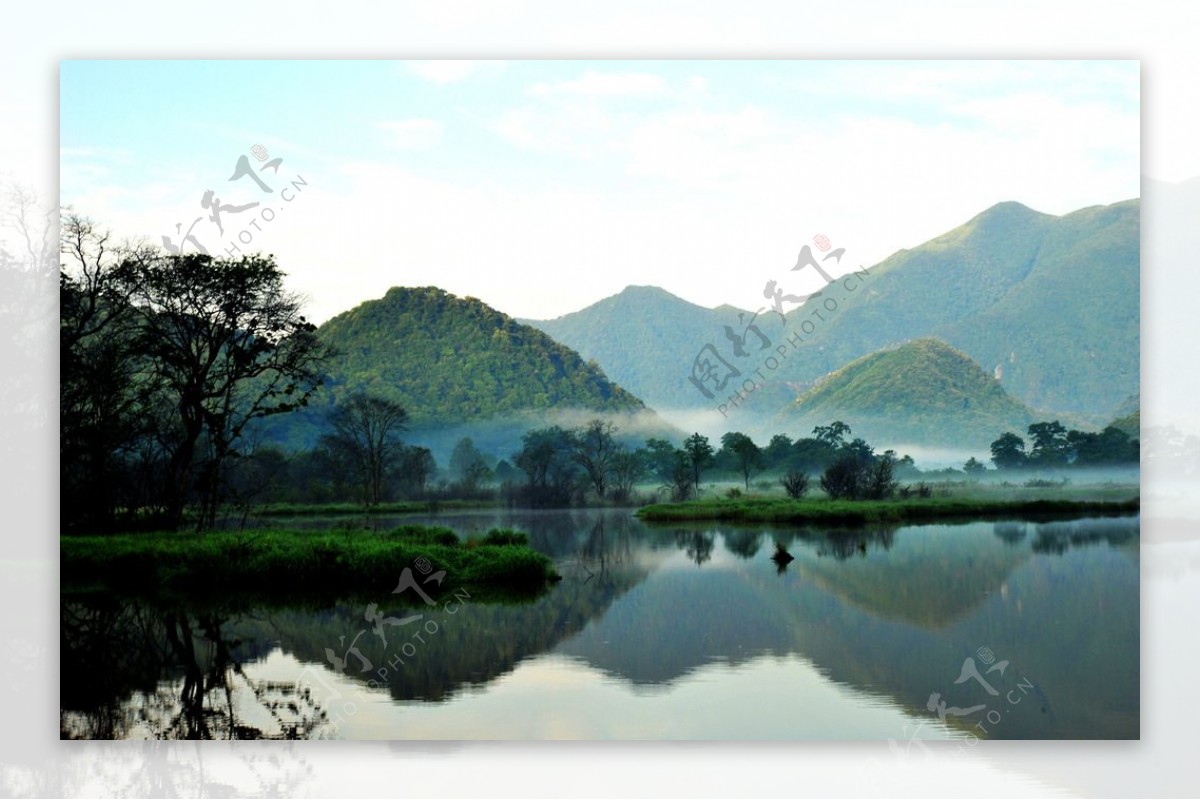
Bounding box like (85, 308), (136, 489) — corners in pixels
(60, 525), (557, 599)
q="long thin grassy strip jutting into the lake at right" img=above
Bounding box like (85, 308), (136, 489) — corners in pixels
(637, 497), (1139, 524)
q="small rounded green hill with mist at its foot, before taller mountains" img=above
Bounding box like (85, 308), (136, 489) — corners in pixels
(787, 338), (1034, 446)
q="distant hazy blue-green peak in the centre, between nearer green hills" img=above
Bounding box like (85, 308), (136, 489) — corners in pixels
(521, 287), (742, 408)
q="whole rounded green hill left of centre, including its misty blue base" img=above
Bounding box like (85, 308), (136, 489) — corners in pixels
(257, 287), (683, 464)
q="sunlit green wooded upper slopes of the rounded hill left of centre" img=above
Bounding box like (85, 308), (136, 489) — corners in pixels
(318, 288), (644, 425)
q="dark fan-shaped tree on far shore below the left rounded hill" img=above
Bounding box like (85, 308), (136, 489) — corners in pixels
(323, 395), (408, 505)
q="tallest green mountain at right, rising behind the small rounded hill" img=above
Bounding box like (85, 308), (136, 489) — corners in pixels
(796, 200), (1140, 422)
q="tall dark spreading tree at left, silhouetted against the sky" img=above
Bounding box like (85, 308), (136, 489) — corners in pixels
(125, 254), (330, 529)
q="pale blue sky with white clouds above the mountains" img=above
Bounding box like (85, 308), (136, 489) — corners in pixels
(60, 60), (1141, 323)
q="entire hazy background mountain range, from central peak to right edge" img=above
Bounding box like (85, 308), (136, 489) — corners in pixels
(534, 199), (1140, 425)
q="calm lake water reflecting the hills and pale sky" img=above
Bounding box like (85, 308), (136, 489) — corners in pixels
(61, 511), (1139, 748)
